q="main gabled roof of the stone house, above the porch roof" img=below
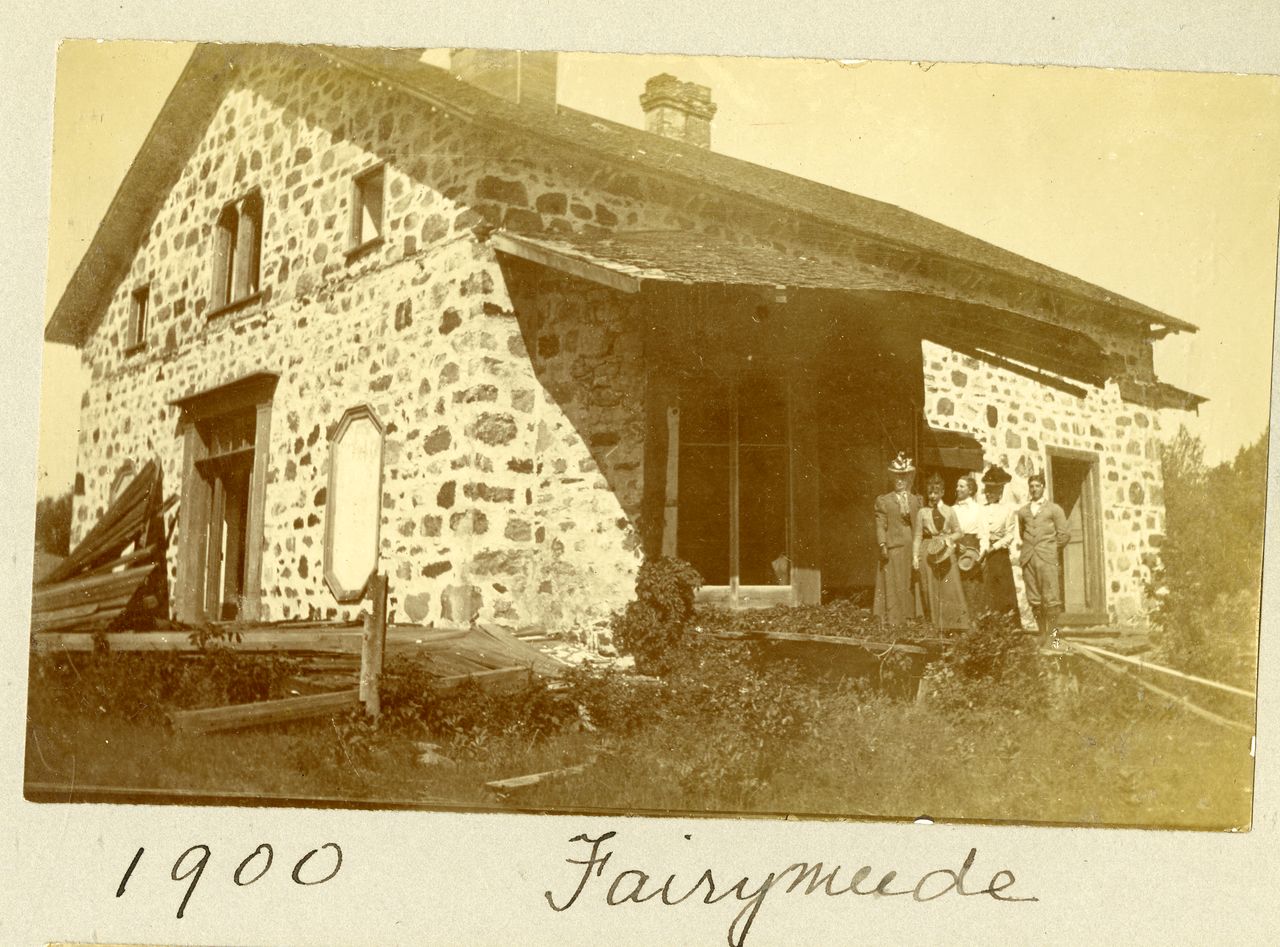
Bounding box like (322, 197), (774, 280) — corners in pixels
(45, 44), (1196, 344)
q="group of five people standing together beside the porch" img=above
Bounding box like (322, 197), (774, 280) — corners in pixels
(876, 453), (1070, 644)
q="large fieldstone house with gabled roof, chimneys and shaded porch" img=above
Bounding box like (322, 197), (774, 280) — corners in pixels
(45, 45), (1201, 631)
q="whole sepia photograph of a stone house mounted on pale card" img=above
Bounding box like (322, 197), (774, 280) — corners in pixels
(24, 42), (1280, 829)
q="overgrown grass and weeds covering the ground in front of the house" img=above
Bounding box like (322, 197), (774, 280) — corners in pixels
(27, 645), (1253, 829)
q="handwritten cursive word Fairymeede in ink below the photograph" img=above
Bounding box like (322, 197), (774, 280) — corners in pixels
(544, 832), (1039, 947)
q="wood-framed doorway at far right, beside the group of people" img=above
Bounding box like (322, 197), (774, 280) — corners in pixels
(1047, 448), (1107, 625)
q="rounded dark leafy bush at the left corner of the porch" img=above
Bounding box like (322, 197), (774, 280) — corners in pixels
(611, 555), (703, 673)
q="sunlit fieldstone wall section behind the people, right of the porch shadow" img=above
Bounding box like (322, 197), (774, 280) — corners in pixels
(923, 342), (1165, 622)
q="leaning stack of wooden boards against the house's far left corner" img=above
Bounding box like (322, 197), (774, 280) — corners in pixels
(31, 461), (175, 635)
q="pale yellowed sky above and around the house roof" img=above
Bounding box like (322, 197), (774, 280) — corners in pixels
(38, 41), (1280, 495)
